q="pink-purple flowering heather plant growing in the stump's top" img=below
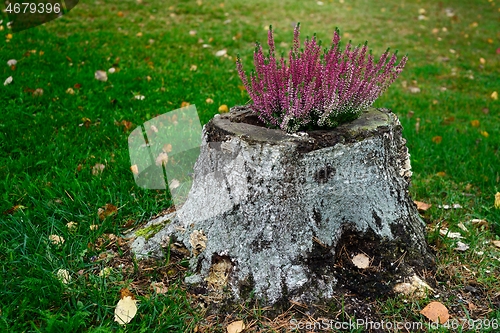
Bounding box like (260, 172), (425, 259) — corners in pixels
(237, 24), (408, 132)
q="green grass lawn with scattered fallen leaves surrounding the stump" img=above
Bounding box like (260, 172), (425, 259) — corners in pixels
(0, 0), (500, 332)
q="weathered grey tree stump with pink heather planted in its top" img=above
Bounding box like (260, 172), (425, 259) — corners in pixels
(133, 107), (433, 304)
